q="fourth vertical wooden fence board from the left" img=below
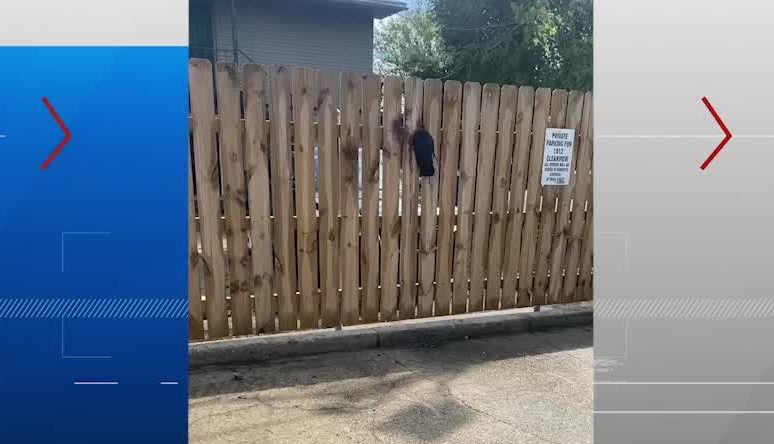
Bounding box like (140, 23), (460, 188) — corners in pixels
(270, 66), (298, 331)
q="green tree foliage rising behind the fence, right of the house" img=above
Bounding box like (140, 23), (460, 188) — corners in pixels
(376, 0), (593, 90)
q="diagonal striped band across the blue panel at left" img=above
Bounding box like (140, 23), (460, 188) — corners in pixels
(0, 299), (188, 319)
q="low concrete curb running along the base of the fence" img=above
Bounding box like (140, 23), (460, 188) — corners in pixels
(188, 303), (593, 368)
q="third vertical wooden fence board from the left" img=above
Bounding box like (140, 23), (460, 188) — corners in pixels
(244, 65), (276, 333)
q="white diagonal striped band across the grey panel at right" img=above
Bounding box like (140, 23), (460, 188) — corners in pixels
(594, 297), (774, 319)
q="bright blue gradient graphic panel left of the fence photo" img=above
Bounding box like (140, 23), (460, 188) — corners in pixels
(0, 47), (188, 443)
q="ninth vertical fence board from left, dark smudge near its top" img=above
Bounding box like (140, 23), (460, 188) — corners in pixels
(379, 77), (403, 321)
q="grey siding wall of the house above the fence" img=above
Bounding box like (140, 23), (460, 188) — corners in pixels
(212, 0), (373, 72)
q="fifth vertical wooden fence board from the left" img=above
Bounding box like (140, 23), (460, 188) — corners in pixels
(292, 68), (319, 329)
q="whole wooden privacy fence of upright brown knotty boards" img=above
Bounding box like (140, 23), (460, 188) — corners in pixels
(189, 59), (594, 339)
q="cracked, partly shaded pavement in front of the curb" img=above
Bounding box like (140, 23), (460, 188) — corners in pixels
(189, 325), (593, 444)
